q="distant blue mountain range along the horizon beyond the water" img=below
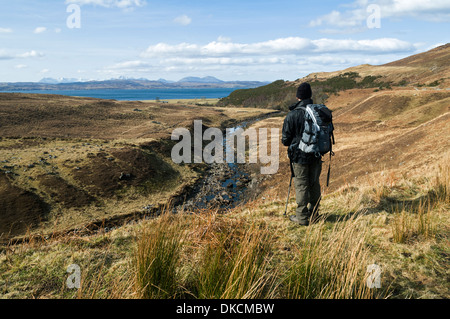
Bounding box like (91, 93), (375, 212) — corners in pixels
(0, 76), (270, 91)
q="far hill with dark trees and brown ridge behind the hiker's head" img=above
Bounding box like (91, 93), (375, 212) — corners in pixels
(218, 44), (450, 110)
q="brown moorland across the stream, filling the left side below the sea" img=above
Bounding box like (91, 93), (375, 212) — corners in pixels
(0, 93), (274, 242)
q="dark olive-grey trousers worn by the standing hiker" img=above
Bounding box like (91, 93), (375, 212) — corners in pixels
(292, 159), (322, 223)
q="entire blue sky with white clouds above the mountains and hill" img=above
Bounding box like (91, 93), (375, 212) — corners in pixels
(0, 0), (450, 82)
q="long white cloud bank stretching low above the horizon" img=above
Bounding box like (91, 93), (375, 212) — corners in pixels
(134, 37), (419, 80)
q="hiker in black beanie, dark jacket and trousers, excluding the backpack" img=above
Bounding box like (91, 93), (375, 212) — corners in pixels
(281, 82), (322, 226)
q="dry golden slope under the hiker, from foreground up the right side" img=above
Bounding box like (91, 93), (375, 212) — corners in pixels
(0, 89), (450, 299)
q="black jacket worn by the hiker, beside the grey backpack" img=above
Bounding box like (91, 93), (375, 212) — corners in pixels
(281, 99), (320, 164)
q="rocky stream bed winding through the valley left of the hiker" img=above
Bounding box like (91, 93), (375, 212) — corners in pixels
(4, 111), (280, 244)
